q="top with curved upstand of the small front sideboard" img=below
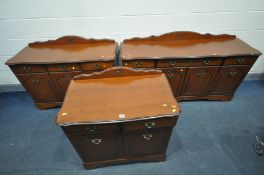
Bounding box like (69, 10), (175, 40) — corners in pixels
(56, 67), (180, 126)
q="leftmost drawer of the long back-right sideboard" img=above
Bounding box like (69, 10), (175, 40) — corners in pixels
(123, 60), (155, 68)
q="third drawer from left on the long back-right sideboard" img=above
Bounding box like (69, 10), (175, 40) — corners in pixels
(188, 58), (223, 66)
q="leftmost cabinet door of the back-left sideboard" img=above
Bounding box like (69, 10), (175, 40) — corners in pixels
(17, 73), (61, 103)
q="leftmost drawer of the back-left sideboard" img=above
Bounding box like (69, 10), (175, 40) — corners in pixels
(10, 64), (46, 74)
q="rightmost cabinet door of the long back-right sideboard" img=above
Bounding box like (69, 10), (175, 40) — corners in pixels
(209, 66), (251, 95)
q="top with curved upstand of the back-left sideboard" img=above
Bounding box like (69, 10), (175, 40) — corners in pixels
(6, 36), (117, 65)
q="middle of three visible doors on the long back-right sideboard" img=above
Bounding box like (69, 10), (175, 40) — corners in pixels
(182, 66), (219, 96)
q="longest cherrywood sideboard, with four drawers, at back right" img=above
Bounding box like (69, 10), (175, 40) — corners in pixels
(120, 32), (261, 101)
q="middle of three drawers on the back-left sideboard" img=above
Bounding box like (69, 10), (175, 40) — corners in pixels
(47, 64), (80, 72)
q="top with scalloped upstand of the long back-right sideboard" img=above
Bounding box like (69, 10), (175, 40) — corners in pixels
(121, 32), (261, 60)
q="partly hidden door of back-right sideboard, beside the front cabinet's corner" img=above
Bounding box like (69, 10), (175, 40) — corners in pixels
(161, 67), (186, 96)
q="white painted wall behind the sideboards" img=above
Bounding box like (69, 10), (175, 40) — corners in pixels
(0, 0), (264, 84)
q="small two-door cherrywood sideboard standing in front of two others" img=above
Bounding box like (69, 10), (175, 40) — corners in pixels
(56, 67), (180, 169)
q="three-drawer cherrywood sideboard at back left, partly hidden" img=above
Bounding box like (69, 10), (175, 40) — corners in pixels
(6, 36), (117, 109)
